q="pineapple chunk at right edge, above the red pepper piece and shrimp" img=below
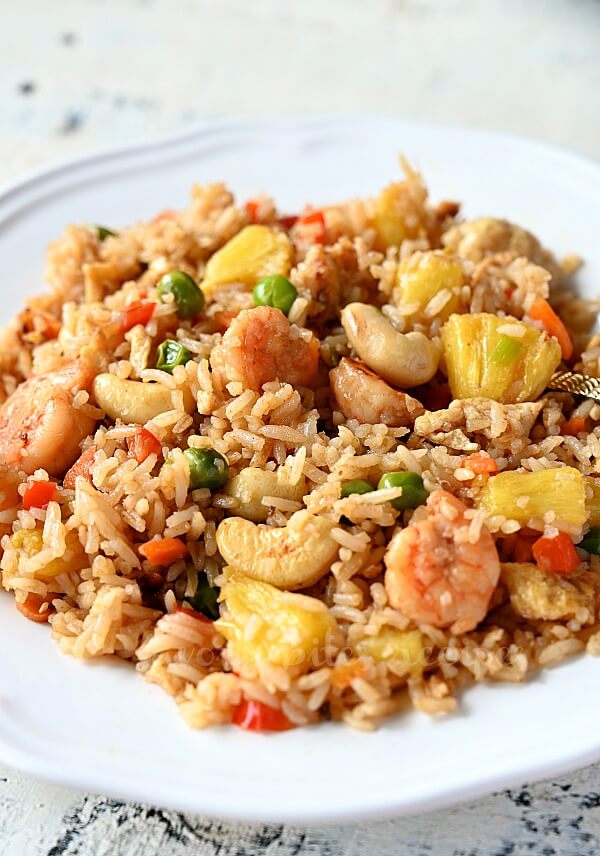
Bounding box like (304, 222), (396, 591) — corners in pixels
(479, 467), (587, 530)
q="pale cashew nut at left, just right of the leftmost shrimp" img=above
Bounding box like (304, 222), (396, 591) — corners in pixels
(92, 373), (196, 425)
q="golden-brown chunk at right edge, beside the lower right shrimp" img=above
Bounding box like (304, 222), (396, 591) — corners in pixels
(502, 562), (598, 621)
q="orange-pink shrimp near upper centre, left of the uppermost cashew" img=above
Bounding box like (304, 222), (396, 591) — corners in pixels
(210, 306), (319, 392)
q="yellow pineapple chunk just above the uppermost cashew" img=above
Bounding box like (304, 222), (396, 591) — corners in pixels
(394, 251), (465, 321)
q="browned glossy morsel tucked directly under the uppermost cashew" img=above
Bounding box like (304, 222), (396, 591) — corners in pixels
(329, 357), (425, 428)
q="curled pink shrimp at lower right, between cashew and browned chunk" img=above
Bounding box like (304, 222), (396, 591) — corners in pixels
(385, 490), (500, 634)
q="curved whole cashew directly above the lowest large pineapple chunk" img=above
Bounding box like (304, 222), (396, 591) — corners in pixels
(217, 510), (339, 591)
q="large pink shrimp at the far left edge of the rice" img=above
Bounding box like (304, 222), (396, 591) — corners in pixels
(0, 361), (95, 476)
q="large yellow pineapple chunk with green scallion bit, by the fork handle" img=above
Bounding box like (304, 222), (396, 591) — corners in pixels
(442, 312), (561, 404)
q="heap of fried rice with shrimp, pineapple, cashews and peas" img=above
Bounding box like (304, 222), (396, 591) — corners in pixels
(0, 163), (600, 730)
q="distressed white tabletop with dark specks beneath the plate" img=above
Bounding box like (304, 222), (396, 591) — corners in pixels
(0, 0), (600, 856)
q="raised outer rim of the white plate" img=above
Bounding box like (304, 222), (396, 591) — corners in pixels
(0, 113), (600, 825)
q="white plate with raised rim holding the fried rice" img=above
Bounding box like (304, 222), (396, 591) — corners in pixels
(0, 119), (600, 822)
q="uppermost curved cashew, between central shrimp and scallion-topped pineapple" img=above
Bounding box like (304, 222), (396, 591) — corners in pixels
(341, 303), (440, 389)
